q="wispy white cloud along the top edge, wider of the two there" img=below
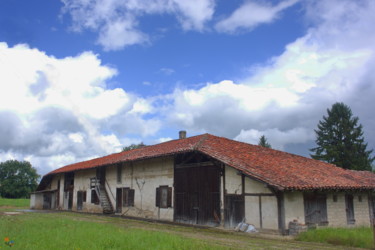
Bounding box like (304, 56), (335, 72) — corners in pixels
(61, 0), (215, 50)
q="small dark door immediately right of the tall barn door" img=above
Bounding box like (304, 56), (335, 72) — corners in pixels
(224, 195), (245, 227)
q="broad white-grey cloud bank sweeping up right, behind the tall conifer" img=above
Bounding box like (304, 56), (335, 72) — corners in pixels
(168, 1), (375, 155)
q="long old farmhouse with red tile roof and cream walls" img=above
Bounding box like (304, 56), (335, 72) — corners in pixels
(30, 131), (375, 233)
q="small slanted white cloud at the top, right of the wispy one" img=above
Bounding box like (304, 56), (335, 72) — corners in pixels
(216, 0), (298, 33)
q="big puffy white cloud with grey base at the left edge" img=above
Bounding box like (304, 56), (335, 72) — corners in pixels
(0, 43), (160, 174)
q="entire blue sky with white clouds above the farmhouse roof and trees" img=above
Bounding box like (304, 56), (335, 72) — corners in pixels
(0, 0), (375, 174)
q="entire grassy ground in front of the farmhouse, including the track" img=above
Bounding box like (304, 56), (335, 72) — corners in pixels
(0, 199), (372, 250)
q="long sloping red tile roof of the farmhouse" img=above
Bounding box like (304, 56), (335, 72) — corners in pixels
(47, 134), (375, 190)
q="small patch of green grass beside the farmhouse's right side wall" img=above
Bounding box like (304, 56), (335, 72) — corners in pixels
(296, 227), (374, 248)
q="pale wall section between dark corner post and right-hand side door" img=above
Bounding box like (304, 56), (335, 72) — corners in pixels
(284, 192), (305, 228)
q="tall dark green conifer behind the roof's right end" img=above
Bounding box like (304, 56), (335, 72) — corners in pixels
(310, 103), (375, 171)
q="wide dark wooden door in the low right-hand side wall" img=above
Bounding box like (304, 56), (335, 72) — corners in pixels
(304, 193), (328, 226)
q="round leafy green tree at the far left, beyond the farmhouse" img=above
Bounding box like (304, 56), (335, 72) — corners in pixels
(0, 160), (39, 198)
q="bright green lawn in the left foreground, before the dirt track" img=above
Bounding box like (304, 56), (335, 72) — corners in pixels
(0, 213), (226, 249)
